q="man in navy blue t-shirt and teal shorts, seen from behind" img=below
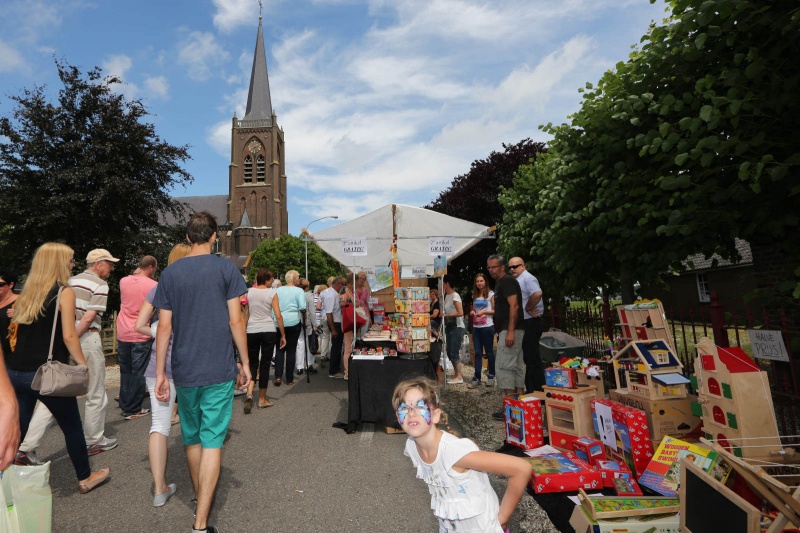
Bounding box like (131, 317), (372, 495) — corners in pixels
(153, 211), (251, 533)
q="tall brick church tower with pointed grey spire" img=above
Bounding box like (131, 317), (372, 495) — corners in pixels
(222, 16), (289, 263)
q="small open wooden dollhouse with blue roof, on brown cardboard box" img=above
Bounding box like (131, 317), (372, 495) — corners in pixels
(613, 339), (689, 400)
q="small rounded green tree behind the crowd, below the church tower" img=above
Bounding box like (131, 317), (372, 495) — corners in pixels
(247, 234), (347, 288)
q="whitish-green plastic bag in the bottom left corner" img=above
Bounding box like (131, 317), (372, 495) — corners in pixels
(0, 462), (53, 533)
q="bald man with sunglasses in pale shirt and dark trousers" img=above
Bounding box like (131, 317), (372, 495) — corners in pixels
(508, 257), (545, 394)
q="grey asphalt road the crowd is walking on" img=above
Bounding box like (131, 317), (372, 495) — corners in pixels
(38, 362), (437, 533)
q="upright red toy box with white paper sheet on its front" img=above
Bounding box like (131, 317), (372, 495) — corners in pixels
(590, 399), (653, 476)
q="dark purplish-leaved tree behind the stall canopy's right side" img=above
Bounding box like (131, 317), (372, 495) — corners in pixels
(425, 139), (546, 292)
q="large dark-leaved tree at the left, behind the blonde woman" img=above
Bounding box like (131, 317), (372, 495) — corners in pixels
(0, 61), (192, 275)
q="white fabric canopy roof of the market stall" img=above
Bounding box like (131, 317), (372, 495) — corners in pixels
(307, 204), (494, 275)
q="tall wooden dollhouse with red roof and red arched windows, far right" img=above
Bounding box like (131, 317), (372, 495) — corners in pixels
(692, 337), (782, 459)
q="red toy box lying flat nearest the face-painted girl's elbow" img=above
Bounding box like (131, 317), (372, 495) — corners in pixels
(526, 452), (603, 494)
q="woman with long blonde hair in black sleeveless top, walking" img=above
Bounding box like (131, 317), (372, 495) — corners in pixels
(5, 242), (109, 494)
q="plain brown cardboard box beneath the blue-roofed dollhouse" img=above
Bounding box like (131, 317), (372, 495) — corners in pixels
(609, 390), (703, 446)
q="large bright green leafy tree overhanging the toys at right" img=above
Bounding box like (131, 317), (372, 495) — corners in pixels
(501, 0), (800, 297)
